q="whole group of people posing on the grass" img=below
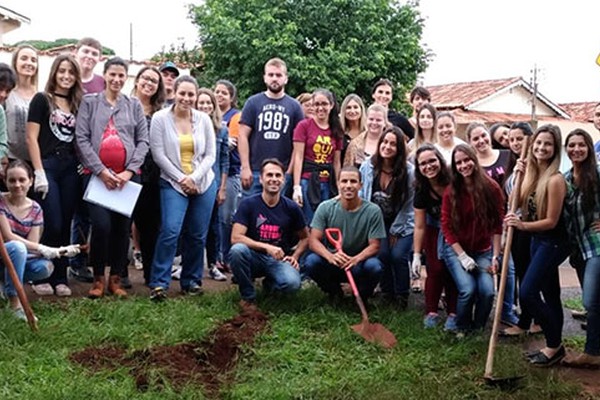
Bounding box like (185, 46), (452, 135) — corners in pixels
(0, 46), (600, 366)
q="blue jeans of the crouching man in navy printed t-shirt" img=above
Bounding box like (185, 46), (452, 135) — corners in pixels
(229, 243), (300, 301)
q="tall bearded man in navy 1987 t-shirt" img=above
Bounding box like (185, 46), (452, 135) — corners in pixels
(238, 58), (304, 196)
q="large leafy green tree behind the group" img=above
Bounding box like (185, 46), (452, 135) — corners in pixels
(190, 0), (429, 107)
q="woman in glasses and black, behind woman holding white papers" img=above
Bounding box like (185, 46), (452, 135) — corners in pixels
(131, 67), (166, 284)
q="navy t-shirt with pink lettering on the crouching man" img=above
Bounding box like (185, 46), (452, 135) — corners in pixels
(233, 193), (306, 254)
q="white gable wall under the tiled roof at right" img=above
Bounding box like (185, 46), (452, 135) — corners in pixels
(469, 86), (556, 116)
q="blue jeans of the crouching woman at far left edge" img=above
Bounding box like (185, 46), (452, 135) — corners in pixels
(4, 241), (52, 297)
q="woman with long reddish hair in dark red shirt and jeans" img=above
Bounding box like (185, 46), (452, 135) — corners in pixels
(441, 144), (505, 335)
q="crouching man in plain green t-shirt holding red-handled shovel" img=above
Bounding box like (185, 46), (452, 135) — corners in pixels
(304, 166), (386, 299)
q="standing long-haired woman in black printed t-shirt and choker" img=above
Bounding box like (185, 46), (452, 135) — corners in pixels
(26, 54), (83, 296)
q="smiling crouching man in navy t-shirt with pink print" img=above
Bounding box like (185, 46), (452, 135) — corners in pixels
(229, 158), (308, 308)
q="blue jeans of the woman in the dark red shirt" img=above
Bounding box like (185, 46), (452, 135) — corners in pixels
(443, 244), (494, 330)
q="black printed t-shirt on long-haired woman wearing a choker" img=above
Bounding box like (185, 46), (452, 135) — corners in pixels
(27, 92), (76, 158)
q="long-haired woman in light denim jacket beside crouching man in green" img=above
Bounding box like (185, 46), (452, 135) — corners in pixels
(359, 126), (414, 309)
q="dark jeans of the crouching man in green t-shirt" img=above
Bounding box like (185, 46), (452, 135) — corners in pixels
(303, 253), (383, 299)
